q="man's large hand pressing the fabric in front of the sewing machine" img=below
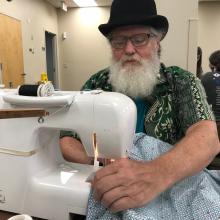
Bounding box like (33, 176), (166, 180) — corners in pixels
(92, 159), (168, 212)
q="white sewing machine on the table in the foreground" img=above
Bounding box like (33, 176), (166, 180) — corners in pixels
(0, 89), (136, 220)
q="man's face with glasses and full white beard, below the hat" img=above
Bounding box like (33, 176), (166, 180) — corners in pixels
(109, 26), (160, 98)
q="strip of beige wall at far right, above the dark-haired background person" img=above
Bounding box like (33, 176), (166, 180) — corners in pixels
(198, 1), (220, 73)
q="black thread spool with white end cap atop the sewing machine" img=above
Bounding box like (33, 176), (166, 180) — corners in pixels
(17, 82), (54, 97)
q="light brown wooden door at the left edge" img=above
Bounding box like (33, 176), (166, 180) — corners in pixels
(0, 14), (25, 88)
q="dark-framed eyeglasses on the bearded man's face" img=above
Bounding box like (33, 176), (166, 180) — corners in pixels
(109, 33), (156, 49)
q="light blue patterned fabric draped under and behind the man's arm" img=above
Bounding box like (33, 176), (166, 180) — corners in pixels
(87, 133), (220, 220)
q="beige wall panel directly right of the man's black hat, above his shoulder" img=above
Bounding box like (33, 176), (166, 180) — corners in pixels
(156, 0), (198, 73)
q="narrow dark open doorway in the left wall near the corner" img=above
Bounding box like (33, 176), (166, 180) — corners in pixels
(45, 31), (59, 89)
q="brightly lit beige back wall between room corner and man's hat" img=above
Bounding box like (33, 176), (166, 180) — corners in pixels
(58, 7), (110, 90)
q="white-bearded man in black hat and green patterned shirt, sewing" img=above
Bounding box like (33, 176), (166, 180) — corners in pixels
(60, 0), (220, 215)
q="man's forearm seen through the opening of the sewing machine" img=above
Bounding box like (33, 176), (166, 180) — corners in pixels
(60, 136), (92, 164)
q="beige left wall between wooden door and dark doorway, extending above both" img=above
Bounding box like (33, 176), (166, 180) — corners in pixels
(0, 0), (58, 83)
